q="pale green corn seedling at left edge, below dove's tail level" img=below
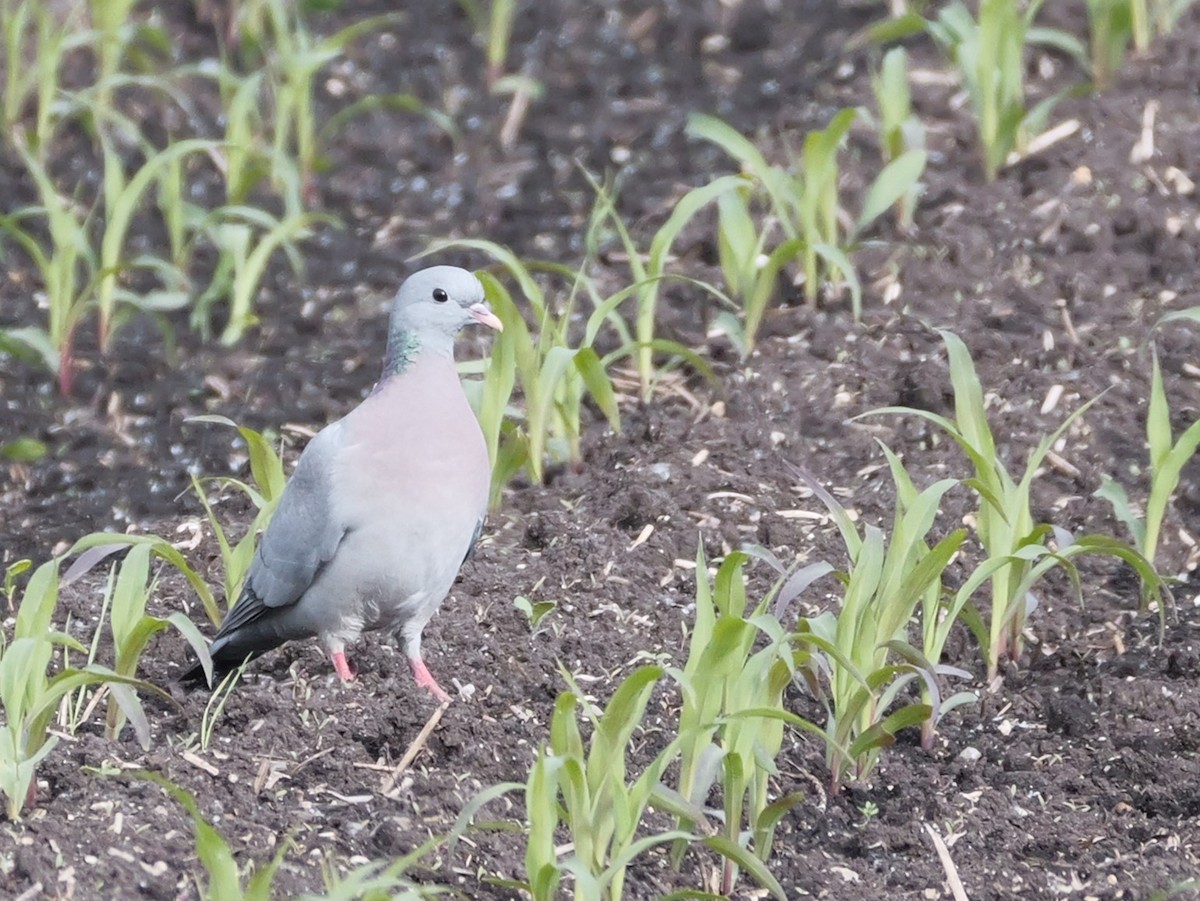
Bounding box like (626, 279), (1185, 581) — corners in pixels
(0, 560), (170, 821)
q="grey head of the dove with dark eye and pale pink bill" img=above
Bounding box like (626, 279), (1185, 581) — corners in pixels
(383, 266), (504, 378)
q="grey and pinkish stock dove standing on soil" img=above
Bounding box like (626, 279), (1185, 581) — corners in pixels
(185, 266), (503, 701)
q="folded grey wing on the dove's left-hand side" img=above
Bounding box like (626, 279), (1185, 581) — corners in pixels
(216, 424), (348, 639)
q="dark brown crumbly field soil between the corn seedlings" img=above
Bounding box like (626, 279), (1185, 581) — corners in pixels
(0, 0), (1200, 899)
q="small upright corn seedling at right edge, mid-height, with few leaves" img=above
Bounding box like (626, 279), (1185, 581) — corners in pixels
(1096, 353), (1200, 573)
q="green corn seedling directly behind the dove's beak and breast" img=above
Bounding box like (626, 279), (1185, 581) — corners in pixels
(430, 240), (620, 501)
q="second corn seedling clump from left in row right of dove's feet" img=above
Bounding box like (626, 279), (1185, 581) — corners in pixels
(667, 546), (823, 895)
